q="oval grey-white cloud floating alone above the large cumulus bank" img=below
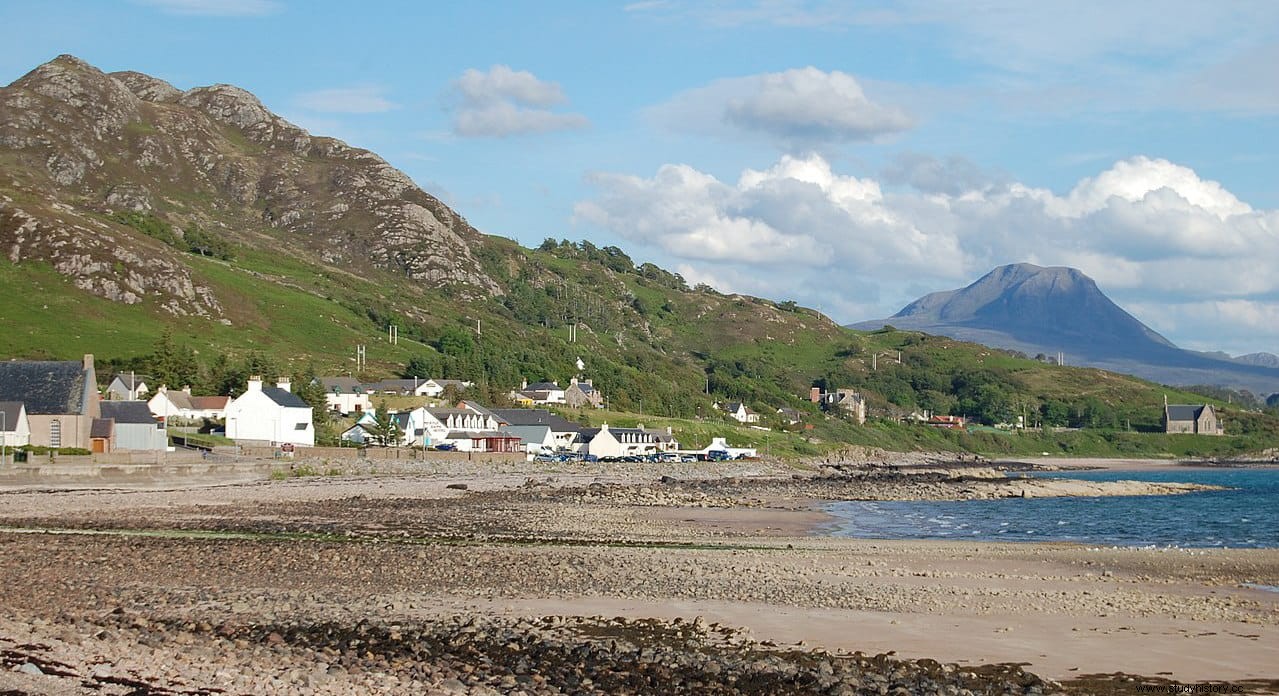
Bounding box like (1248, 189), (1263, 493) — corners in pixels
(651, 67), (913, 150)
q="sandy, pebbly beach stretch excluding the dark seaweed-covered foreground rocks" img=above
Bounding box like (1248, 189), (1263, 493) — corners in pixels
(0, 461), (1279, 682)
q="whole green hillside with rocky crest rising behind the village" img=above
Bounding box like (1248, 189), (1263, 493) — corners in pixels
(0, 56), (1275, 454)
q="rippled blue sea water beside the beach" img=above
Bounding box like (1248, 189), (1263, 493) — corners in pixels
(825, 467), (1279, 549)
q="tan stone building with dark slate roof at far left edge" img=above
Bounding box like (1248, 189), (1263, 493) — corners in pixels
(0, 354), (102, 449)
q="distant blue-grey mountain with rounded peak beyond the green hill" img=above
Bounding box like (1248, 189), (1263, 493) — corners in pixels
(851, 264), (1279, 394)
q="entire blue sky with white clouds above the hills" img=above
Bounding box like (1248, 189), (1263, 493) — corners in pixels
(0, 0), (1279, 354)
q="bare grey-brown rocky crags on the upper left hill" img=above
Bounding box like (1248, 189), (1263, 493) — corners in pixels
(0, 55), (501, 315)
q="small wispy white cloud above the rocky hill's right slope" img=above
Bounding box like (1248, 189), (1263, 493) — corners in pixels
(453, 65), (591, 137)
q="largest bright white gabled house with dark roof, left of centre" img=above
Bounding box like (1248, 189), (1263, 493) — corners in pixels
(226, 376), (316, 447)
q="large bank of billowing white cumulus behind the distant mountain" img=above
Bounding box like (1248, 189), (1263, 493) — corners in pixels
(574, 155), (1279, 352)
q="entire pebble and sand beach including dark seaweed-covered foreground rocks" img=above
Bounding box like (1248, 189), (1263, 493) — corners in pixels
(0, 462), (1279, 695)
